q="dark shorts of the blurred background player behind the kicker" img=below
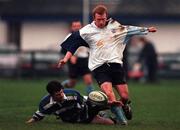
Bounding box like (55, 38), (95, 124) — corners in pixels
(68, 58), (91, 79)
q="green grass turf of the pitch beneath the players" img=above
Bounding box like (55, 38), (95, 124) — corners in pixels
(0, 79), (180, 130)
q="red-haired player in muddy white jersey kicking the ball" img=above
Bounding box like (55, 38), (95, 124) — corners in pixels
(58, 5), (156, 125)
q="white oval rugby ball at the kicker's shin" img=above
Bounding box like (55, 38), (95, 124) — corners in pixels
(88, 91), (108, 105)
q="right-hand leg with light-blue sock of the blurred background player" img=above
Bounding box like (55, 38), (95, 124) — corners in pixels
(83, 73), (94, 94)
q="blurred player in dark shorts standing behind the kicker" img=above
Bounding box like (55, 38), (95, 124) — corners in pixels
(62, 21), (93, 94)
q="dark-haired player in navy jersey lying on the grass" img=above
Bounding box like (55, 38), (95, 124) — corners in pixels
(26, 81), (114, 124)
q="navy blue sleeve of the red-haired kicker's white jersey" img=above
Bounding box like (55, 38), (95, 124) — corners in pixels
(61, 31), (89, 54)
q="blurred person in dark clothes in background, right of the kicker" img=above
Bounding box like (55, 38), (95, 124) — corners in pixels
(138, 37), (158, 82)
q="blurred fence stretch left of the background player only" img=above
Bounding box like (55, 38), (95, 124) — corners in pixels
(0, 51), (66, 77)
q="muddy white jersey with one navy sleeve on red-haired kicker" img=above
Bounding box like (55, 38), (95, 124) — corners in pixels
(61, 19), (148, 71)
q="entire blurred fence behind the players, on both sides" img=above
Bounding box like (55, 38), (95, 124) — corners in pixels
(0, 51), (180, 78)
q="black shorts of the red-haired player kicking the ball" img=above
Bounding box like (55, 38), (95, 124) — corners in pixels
(93, 63), (126, 85)
